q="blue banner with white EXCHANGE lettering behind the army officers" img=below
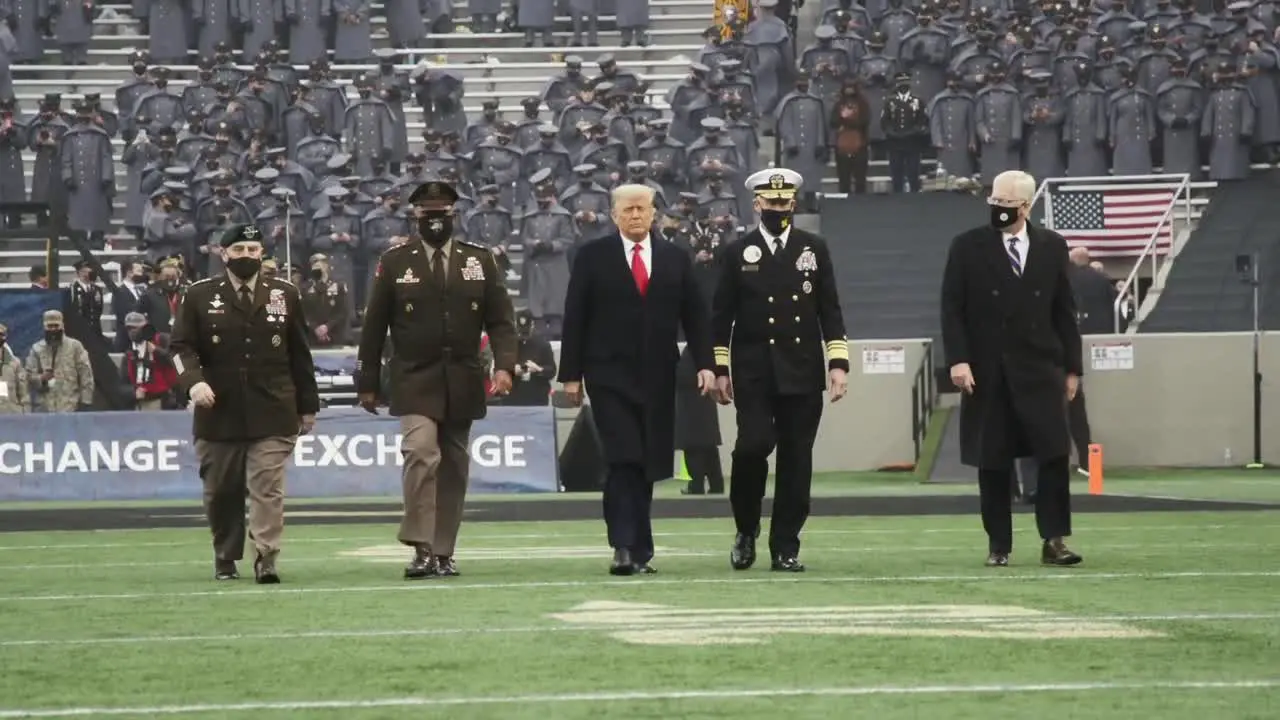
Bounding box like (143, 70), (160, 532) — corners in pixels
(0, 407), (559, 501)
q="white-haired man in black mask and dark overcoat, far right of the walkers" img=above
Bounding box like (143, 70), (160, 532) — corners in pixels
(942, 170), (1084, 568)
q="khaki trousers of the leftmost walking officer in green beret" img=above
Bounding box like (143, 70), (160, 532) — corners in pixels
(196, 436), (298, 562)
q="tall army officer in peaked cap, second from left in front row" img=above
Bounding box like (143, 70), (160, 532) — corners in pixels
(356, 182), (517, 579)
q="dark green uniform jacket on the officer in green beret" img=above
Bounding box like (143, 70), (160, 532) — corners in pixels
(170, 274), (320, 442)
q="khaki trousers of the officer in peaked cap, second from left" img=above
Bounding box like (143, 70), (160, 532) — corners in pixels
(397, 415), (471, 557)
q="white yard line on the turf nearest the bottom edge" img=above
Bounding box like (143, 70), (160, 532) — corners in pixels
(0, 678), (1280, 719)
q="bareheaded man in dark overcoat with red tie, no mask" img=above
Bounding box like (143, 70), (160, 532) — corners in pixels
(559, 184), (716, 575)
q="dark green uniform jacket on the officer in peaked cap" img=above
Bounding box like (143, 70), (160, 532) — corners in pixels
(356, 238), (517, 421)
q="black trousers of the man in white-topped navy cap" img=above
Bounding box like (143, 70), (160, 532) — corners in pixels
(728, 387), (822, 557)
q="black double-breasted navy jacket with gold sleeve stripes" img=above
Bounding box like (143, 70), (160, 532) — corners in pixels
(712, 227), (849, 395)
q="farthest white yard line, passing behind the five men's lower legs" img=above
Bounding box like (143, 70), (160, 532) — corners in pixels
(0, 520), (1280, 552)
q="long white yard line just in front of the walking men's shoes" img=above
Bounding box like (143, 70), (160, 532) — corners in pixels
(0, 569), (1280, 602)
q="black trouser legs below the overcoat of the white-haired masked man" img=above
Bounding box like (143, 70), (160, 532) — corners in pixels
(978, 457), (1071, 552)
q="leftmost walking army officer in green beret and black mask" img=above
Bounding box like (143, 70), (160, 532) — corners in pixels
(170, 225), (320, 584)
